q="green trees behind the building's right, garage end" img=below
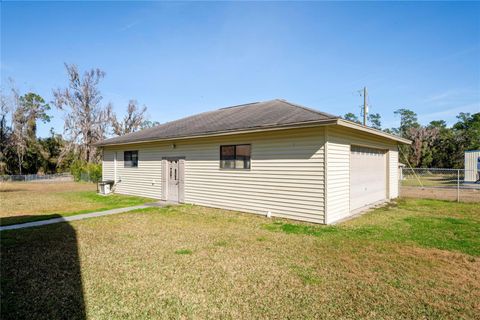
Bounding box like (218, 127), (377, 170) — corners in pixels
(344, 108), (480, 169)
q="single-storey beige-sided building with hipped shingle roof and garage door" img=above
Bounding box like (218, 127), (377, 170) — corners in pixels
(98, 99), (410, 224)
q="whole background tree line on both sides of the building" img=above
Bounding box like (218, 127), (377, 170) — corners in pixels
(0, 64), (480, 175)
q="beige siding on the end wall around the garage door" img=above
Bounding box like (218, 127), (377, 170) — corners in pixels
(325, 126), (398, 223)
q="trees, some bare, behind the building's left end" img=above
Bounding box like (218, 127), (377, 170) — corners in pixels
(0, 64), (158, 175)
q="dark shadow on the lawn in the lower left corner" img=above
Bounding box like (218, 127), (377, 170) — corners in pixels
(0, 215), (86, 320)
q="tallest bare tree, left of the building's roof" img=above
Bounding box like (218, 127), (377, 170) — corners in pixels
(53, 64), (111, 162)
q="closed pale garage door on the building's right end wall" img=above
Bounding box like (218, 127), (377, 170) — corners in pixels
(350, 146), (387, 211)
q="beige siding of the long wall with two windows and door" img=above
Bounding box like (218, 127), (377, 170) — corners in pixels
(101, 127), (325, 223)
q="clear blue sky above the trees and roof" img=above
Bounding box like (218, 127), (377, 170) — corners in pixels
(0, 2), (480, 136)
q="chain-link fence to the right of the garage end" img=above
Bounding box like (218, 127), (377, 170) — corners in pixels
(399, 167), (480, 202)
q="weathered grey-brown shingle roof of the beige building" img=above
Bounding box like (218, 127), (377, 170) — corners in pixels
(97, 99), (339, 146)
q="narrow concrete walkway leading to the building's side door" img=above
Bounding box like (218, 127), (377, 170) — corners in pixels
(0, 202), (166, 231)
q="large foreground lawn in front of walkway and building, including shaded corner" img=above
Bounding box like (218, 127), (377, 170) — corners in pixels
(0, 199), (480, 319)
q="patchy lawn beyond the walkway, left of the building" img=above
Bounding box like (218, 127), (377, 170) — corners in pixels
(0, 182), (152, 225)
